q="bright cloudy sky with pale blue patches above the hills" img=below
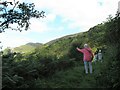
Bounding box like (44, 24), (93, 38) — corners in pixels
(0, 0), (119, 49)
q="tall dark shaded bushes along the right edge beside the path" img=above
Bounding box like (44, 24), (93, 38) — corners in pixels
(95, 14), (120, 88)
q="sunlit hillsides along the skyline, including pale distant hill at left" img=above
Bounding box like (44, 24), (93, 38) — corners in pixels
(14, 24), (105, 55)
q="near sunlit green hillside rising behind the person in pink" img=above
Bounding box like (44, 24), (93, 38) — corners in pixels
(34, 23), (106, 59)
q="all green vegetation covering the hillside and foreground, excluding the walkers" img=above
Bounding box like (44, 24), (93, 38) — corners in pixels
(2, 2), (120, 88)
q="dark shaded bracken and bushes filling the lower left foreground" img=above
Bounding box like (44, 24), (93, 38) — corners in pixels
(2, 53), (74, 88)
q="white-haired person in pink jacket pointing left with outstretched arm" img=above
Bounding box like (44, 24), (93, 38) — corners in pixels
(76, 44), (93, 74)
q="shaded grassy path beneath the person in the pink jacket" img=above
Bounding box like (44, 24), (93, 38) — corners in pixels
(35, 62), (101, 88)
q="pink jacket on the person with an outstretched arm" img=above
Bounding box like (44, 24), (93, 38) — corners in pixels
(77, 48), (93, 61)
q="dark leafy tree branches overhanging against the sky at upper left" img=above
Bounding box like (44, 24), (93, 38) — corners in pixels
(0, 0), (45, 33)
